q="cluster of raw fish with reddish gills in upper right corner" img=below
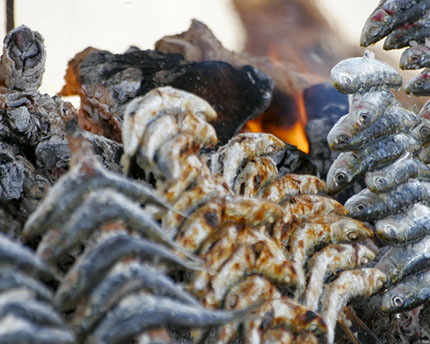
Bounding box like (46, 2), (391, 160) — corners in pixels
(361, 0), (430, 96)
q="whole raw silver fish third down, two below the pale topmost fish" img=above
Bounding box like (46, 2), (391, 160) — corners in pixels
(326, 133), (422, 194)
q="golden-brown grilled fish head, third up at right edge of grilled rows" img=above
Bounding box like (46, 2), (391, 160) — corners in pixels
(330, 217), (373, 242)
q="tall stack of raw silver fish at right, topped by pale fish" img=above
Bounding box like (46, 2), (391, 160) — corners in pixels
(327, 52), (430, 312)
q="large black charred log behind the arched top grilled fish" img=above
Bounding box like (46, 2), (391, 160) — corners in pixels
(67, 50), (273, 144)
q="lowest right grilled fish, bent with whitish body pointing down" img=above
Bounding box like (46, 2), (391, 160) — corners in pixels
(321, 268), (387, 344)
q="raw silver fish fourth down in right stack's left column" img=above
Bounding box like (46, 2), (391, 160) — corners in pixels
(345, 179), (430, 221)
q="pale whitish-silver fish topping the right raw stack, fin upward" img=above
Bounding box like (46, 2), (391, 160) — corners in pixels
(330, 50), (402, 93)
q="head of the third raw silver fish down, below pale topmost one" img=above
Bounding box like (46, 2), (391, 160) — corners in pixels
(326, 152), (361, 195)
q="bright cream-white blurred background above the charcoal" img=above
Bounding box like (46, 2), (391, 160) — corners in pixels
(0, 0), (398, 94)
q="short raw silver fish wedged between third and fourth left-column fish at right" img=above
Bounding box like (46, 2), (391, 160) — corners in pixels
(365, 153), (430, 193)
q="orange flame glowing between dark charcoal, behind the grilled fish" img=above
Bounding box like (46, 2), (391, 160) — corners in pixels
(247, 94), (309, 153)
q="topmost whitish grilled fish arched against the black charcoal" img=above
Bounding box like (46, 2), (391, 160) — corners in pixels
(121, 86), (217, 173)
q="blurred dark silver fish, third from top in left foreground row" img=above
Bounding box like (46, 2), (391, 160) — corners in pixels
(55, 233), (202, 310)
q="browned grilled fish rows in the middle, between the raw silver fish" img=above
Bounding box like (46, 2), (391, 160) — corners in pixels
(116, 88), (385, 343)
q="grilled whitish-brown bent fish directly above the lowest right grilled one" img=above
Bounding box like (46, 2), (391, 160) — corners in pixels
(304, 244), (375, 312)
